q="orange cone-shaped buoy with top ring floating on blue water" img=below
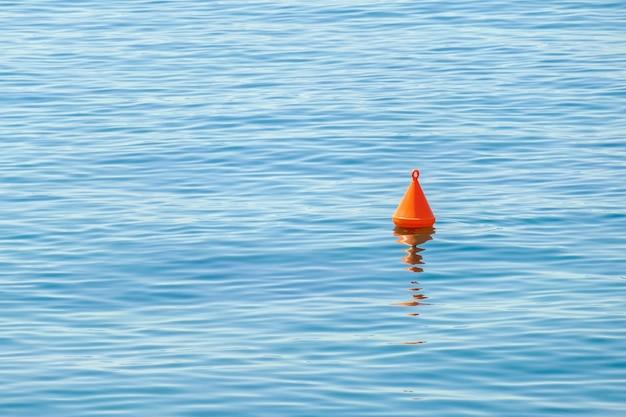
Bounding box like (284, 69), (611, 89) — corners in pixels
(392, 169), (435, 229)
